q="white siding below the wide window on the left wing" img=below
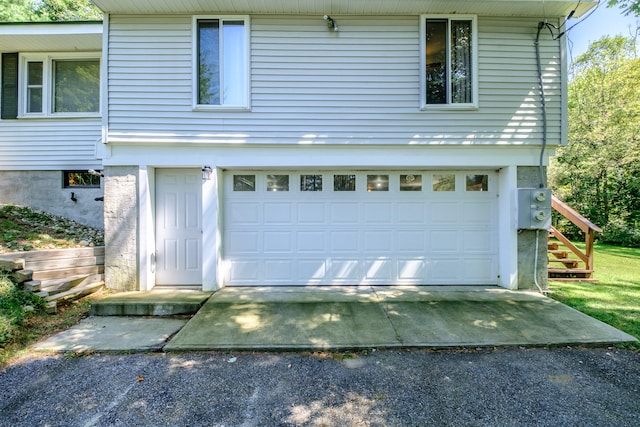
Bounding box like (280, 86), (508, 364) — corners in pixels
(0, 119), (102, 170)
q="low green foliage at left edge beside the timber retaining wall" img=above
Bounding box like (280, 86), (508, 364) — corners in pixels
(0, 272), (45, 346)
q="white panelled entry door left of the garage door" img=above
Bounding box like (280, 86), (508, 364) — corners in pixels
(156, 169), (202, 287)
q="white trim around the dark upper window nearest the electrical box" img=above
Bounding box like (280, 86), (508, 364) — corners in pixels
(420, 15), (478, 111)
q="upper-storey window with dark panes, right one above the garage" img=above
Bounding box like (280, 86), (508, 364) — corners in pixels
(420, 15), (478, 109)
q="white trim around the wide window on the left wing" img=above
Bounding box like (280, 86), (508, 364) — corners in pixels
(18, 52), (103, 119)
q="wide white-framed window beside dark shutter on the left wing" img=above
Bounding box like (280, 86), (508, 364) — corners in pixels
(18, 53), (100, 118)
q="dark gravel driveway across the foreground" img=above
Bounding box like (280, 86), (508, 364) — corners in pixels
(0, 348), (640, 426)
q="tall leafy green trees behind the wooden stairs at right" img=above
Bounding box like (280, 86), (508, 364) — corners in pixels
(549, 36), (640, 246)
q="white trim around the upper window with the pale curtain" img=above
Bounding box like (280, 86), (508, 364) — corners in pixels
(191, 15), (251, 111)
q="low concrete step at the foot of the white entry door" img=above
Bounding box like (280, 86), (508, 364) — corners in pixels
(91, 289), (213, 316)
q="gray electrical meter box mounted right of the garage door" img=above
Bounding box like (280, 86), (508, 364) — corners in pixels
(518, 188), (551, 230)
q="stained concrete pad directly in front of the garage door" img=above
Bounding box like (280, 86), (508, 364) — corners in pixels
(164, 287), (635, 351)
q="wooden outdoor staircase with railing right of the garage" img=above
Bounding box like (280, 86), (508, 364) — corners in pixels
(547, 196), (602, 282)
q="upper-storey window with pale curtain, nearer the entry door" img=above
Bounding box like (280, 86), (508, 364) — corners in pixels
(193, 16), (250, 110)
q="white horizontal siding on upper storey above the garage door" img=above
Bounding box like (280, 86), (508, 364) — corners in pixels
(108, 15), (562, 145)
